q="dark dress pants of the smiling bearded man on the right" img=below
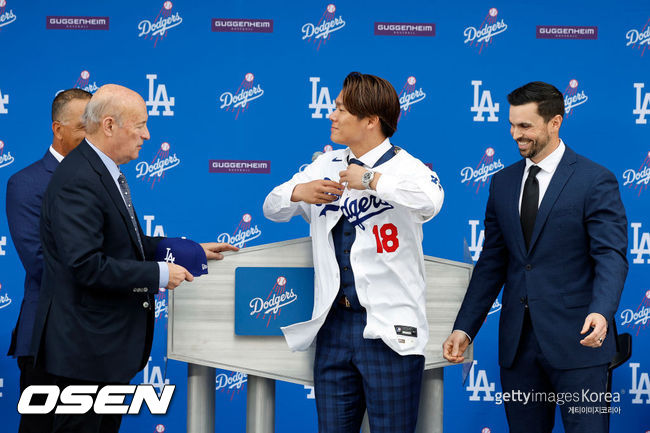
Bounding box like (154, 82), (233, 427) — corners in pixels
(501, 310), (609, 433)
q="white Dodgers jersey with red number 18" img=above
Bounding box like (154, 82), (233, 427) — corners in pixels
(264, 139), (444, 355)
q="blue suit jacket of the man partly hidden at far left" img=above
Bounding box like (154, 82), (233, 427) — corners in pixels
(7, 150), (59, 356)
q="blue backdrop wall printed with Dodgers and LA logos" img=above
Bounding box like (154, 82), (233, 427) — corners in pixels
(0, 0), (650, 433)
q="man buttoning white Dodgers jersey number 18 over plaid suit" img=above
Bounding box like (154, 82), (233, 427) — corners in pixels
(264, 72), (444, 433)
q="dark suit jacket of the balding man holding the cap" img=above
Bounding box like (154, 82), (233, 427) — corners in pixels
(32, 140), (160, 383)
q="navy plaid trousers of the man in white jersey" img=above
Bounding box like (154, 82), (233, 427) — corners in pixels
(314, 304), (424, 433)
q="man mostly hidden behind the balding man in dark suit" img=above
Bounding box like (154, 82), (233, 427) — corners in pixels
(7, 89), (92, 433)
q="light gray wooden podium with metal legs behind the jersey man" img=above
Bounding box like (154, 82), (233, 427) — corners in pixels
(167, 238), (473, 433)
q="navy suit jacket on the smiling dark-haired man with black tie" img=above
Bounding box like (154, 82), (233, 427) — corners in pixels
(454, 147), (628, 369)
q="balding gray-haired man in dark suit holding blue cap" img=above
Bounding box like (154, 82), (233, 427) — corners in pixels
(32, 84), (237, 433)
